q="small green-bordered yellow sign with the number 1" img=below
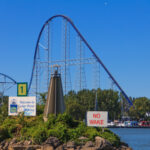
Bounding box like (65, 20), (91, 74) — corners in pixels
(17, 82), (28, 96)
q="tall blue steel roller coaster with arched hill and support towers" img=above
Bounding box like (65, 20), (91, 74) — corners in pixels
(0, 15), (133, 106)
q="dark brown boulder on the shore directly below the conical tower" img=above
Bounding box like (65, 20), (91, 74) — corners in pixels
(44, 137), (61, 148)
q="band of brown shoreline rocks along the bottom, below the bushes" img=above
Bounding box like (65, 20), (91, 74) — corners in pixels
(0, 136), (132, 150)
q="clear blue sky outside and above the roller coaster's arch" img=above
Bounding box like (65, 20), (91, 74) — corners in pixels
(0, 0), (150, 98)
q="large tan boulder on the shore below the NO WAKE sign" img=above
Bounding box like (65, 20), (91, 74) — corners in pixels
(95, 136), (114, 150)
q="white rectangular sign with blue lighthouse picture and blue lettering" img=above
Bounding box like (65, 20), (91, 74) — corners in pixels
(8, 97), (36, 116)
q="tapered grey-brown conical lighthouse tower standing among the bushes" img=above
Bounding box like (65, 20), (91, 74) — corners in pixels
(44, 68), (65, 121)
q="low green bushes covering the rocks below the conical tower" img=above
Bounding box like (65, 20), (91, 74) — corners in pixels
(0, 113), (120, 146)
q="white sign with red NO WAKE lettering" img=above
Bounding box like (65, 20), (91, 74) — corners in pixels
(87, 111), (108, 127)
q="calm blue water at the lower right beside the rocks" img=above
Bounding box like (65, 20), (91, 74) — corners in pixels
(111, 128), (150, 150)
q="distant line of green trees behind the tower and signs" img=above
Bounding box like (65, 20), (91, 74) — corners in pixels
(0, 89), (150, 121)
